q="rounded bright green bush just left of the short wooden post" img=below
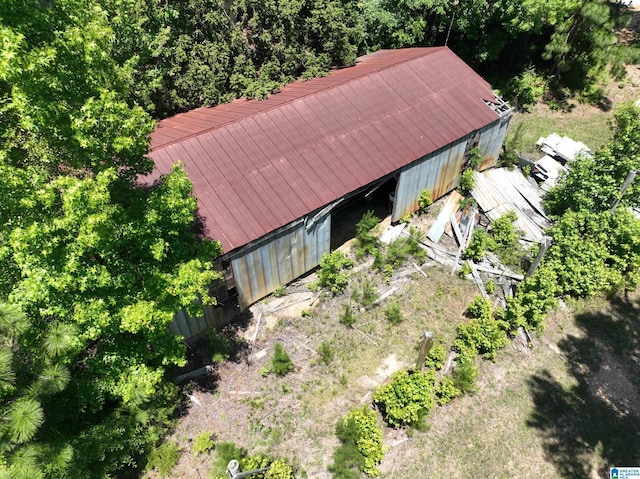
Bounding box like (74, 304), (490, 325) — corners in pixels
(373, 371), (435, 427)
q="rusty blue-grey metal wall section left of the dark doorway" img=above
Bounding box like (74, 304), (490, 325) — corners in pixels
(231, 214), (331, 308)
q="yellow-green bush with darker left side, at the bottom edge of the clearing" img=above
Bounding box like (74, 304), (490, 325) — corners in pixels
(329, 406), (384, 478)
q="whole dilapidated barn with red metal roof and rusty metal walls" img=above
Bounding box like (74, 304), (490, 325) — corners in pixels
(145, 47), (511, 322)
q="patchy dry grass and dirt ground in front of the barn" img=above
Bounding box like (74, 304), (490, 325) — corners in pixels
(154, 199), (640, 479)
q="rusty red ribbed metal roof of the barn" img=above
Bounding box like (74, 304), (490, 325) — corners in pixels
(142, 47), (498, 252)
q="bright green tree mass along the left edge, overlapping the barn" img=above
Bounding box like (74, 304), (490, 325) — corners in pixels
(0, 0), (220, 478)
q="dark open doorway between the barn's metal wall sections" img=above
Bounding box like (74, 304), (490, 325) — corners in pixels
(331, 177), (398, 251)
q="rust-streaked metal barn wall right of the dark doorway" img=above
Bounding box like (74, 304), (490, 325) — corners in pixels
(391, 117), (509, 222)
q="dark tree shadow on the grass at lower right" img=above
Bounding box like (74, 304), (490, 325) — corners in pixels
(527, 297), (640, 479)
